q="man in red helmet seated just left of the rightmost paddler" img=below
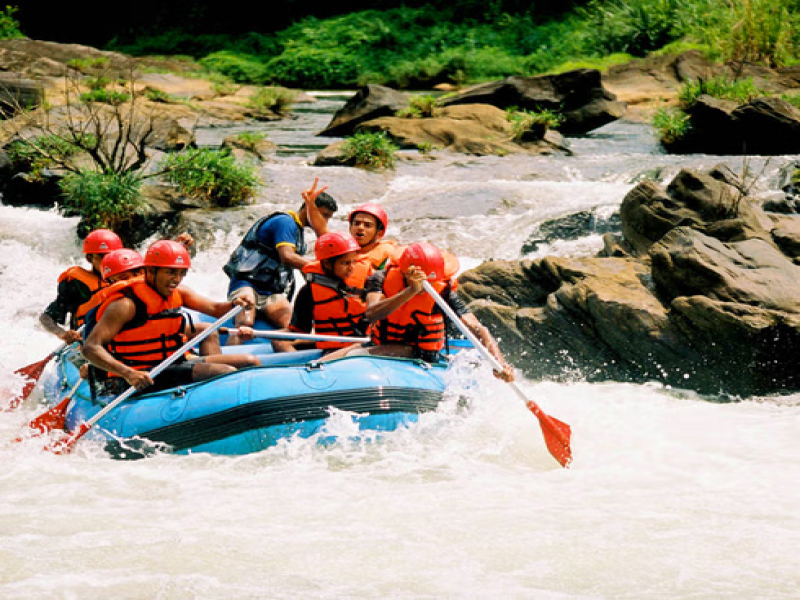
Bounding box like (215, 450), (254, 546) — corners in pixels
(275, 232), (369, 358)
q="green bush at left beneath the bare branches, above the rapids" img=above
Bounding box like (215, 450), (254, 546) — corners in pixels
(59, 170), (142, 230)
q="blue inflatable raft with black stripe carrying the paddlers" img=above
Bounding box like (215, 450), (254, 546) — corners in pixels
(43, 332), (468, 459)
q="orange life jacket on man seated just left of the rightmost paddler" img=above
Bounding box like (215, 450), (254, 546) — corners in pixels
(303, 261), (367, 349)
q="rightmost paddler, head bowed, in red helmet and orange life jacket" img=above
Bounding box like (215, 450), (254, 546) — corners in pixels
(365, 242), (514, 381)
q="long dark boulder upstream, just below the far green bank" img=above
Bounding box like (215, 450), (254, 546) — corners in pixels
(441, 69), (625, 134)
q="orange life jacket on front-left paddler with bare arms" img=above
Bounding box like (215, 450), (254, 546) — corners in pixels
(97, 277), (186, 375)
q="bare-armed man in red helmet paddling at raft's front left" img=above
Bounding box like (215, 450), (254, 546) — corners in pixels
(83, 240), (260, 395)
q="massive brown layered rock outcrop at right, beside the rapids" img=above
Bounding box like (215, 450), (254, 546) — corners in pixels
(459, 168), (800, 395)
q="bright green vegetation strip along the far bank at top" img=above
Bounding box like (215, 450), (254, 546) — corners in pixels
(101, 0), (800, 89)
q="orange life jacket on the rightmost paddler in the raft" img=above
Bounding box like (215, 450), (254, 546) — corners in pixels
(372, 266), (457, 352)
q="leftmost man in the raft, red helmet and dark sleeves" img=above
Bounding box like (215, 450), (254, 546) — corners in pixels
(39, 229), (122, 343)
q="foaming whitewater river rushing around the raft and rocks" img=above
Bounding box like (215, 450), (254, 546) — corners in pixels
(0, 95), (800, 599)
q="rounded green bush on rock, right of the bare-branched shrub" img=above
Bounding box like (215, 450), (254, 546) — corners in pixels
(163, 148), (261, 208)
